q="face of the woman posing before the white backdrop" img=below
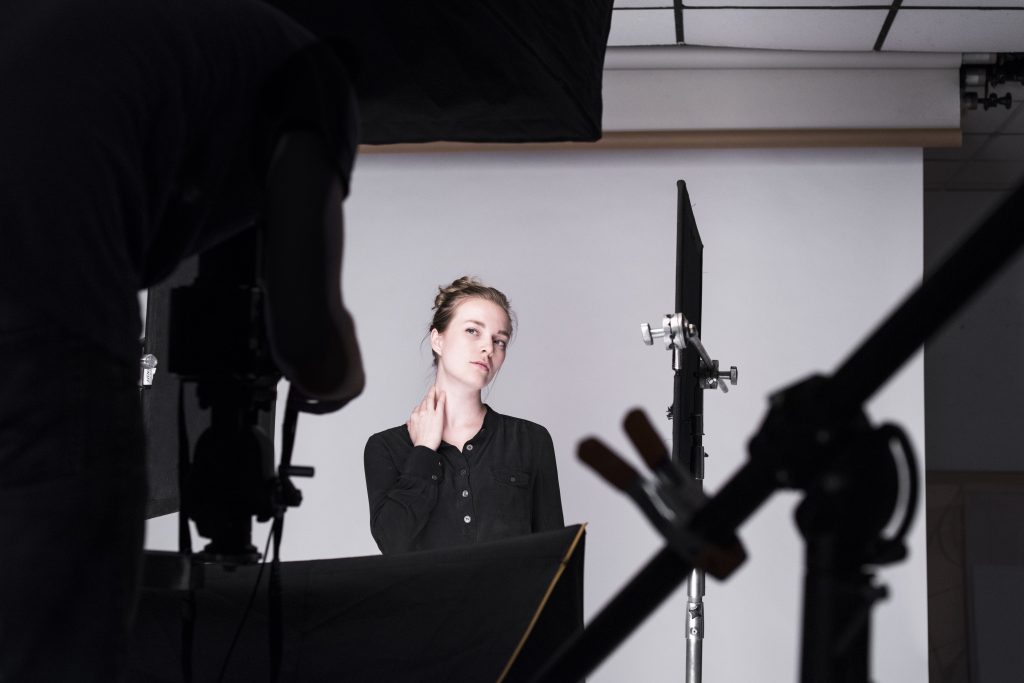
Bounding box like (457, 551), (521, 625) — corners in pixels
(430, 298), (511, 389)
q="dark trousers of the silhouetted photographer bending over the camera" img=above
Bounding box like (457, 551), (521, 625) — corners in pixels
(0, 296), (145, 683)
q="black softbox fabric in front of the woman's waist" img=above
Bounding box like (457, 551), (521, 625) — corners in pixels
(129, 525), (584, 683)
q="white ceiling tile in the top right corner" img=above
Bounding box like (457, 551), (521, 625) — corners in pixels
(883, 9), (1024, 52)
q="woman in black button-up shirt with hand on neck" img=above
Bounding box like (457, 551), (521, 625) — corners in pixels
(365, 278), (563, 554)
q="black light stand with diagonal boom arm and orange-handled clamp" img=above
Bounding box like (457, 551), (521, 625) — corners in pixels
(535, 178), (1024, 683)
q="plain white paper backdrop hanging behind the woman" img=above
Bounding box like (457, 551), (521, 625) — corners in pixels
(147, 145), (928, 683)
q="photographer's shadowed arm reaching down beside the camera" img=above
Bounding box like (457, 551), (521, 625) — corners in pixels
(264, 130), (365, 408)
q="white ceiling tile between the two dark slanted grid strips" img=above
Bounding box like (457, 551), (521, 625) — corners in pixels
(683, 9), (887, 50)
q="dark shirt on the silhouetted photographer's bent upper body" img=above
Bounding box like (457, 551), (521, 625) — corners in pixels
(0, 0), (355, 359)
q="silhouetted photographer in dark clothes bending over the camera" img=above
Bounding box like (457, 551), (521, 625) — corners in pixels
(0, 0), (364, 683)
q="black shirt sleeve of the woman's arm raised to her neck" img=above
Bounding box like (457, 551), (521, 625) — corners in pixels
(364, 434), (441, 555)
